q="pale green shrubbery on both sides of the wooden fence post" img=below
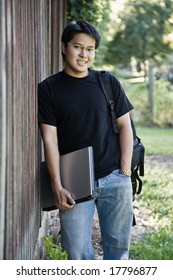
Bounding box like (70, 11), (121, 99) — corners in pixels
(122, 79), (173, 127)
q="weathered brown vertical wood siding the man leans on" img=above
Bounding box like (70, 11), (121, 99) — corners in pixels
(0, 0), (65, 260)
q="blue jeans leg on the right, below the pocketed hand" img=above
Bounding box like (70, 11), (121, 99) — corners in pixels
(96, 170), (133, 260)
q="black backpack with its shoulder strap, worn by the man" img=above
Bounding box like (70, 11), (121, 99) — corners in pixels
(97, 70), (145, 201)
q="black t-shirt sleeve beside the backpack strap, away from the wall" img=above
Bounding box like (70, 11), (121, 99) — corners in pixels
(111, 72), (134, 118)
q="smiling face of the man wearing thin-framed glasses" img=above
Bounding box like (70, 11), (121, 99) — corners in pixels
(62, 33), (96, 78)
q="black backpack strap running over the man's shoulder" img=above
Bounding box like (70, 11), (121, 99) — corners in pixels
(97, 71), (119, 134)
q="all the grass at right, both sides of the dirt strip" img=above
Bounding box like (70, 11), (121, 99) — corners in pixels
(130, 128), (173, 260)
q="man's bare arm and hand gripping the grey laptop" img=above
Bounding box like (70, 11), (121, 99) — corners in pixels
(40, 124), (75, 210)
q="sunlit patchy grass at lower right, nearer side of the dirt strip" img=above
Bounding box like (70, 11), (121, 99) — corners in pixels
(130, 166), (173, 260)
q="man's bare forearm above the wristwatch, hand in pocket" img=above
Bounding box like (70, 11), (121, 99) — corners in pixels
(117, 113), (133, 171)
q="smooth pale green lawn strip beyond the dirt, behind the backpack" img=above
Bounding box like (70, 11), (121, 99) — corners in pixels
(136, 127), (173, 156)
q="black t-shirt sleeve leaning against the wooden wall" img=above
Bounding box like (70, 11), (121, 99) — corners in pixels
(38, 82), (56, 126)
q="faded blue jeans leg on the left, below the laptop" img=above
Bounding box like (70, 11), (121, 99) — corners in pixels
(60, 200), (95, 260)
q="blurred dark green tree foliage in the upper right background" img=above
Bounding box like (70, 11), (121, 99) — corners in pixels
(106, 0), (173, 64)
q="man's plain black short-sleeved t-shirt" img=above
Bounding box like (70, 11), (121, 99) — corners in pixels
(38, 70), (133, 179)
